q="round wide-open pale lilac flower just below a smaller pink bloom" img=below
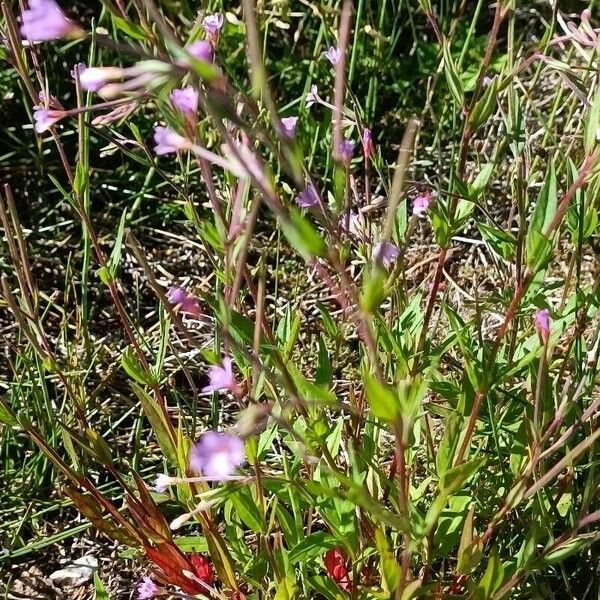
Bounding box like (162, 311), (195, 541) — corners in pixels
(190, 431), (246, 481)
